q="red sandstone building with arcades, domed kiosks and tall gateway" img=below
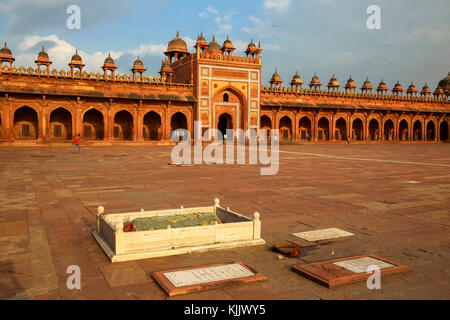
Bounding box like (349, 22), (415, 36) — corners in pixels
(0, 34), (450, 144)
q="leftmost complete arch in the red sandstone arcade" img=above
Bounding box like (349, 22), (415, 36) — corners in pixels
(14, 106), (38, 140)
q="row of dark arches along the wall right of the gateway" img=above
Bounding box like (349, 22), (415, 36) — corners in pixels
(260, 112), (450, 142)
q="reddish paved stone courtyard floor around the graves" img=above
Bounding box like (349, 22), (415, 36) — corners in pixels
(0, 144), (450, 299)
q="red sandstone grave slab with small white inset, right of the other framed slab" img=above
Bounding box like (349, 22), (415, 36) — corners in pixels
(292, 254), (411, 288)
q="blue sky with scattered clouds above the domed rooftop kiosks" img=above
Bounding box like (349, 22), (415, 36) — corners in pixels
(0, 0), (450, 90)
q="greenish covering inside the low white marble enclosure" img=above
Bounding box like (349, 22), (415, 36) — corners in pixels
(132, 213), (221, 231)
